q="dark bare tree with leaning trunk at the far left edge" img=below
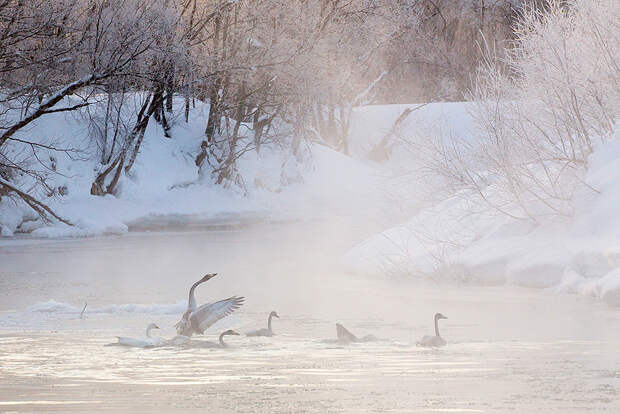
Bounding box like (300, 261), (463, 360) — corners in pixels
(0, 0), (160, 221)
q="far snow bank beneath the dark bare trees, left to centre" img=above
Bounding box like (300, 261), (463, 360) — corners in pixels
(0, 100), (469, 237)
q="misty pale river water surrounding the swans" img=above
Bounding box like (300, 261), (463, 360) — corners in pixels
(0, 223), (620, 413)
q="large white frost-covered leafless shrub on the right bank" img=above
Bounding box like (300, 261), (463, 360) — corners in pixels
(428, 0), (620, 221)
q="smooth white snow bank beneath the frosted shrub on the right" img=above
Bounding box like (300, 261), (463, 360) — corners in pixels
(344, 124), (620, 306)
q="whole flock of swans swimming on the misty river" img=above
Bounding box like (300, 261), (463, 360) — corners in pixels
(109, 273), (448, 348)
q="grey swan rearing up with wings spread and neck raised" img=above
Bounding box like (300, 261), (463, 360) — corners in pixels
(175, 273), (245, 337)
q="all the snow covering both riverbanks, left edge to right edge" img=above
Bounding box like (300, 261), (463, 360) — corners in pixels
(0, 103), (620, 306)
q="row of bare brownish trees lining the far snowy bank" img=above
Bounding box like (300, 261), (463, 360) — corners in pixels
(0, 0), (528, 223)
